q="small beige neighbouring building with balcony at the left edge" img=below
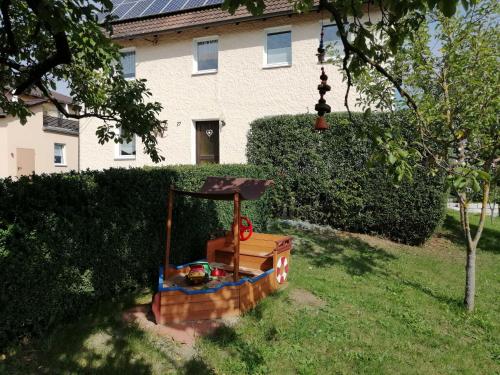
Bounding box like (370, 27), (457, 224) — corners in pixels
(0, 93), (79, 178)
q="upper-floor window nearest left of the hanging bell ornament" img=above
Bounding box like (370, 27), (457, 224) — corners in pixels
(264, 29), (292, 67)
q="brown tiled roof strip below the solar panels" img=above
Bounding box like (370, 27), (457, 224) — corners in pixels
(112, 0), (304, 39)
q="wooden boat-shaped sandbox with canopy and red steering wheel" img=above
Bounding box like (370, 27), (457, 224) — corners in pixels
(152, 177), (292, 324)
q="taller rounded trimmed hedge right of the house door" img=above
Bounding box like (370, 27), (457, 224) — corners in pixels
(247, 112), (446, 245)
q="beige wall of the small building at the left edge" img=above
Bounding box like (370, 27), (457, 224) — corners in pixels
(0, 105), (78, 177)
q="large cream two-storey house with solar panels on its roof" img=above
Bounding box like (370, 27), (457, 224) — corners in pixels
(80, 0), (372, 169)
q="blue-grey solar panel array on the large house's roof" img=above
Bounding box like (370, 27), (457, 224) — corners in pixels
(112, 0), (223, 21)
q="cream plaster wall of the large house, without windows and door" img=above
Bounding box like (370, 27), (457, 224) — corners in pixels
(80, 13), (355, 169)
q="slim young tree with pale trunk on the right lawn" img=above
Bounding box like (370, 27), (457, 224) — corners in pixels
(344, 0), (500, 310)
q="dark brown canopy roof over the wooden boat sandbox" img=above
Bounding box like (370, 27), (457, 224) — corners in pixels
(174, 177), (273, 200)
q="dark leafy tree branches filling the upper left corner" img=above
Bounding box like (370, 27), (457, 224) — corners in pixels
(0, 0), (165, 162)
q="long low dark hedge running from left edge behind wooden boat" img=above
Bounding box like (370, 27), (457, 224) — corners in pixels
(0, 165), (269, 347)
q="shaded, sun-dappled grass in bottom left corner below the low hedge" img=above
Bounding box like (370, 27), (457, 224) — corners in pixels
(0, 296), (213, 375)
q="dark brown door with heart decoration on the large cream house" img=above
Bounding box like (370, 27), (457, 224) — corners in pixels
(196, 121), (219, 164)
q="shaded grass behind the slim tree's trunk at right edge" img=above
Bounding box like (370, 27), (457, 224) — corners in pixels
(441, 215), (500, 254)
